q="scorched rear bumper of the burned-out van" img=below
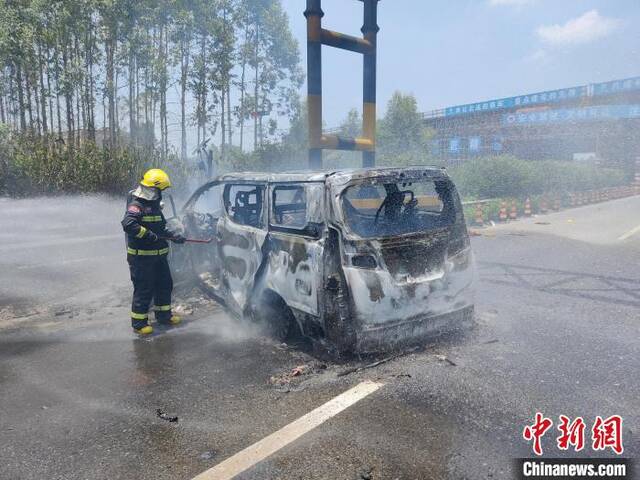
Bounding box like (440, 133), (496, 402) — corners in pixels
(356, 306), (473, 353)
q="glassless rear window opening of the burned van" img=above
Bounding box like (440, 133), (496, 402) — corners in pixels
(342, 180), (460, 238)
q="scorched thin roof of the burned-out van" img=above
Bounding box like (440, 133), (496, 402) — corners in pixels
(219, 165), (448, 184)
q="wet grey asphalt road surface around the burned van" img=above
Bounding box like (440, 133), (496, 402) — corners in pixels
(0, 193), (640, 480)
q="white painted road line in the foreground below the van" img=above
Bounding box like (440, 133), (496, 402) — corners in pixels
(188, 381), (384, 480)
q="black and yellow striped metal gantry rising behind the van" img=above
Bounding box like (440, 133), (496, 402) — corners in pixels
(304, 0), (379, 169)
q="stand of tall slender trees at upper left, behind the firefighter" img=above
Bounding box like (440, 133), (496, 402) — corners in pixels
(0, 0), (302, 165)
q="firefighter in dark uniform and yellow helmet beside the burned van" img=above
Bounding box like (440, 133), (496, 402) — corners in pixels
(122, 168), (185, 335)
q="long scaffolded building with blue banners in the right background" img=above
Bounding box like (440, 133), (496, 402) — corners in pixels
(424, 77), (640, 176)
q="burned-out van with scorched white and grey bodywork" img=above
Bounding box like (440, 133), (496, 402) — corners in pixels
(170, 167), (474, 353)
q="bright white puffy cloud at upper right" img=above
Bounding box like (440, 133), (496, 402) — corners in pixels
(536, 10), (621, 46)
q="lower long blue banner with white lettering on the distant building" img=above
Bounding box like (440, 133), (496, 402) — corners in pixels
(502, 105), (640, 125)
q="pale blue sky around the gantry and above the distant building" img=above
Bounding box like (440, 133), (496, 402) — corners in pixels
(282, 0), (640, 126)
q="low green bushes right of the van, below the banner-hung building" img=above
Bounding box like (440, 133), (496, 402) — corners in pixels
(449, 155), (625, 198)
